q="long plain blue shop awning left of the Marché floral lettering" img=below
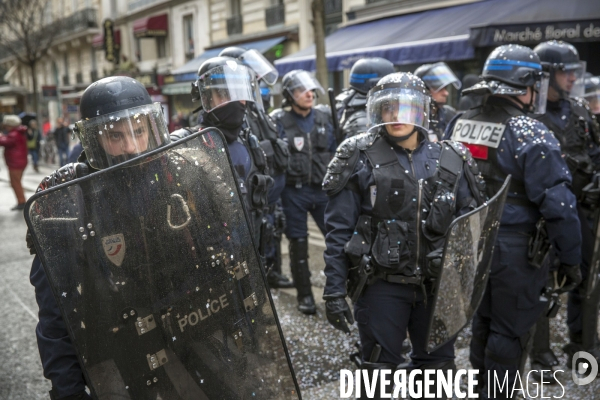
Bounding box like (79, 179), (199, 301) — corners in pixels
(275, 0), (600, 74)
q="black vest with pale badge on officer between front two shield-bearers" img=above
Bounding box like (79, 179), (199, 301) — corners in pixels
(280, 109), (332, 188)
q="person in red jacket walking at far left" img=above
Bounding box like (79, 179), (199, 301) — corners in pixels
(0, 115), (27, 210)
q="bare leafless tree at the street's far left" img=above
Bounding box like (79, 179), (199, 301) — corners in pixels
(0, 0), (61, 115)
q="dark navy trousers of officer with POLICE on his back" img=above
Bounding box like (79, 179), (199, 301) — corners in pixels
(470, 231), (548, 398)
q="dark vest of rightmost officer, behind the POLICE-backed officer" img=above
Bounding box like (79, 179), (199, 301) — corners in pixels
(537, 99), (594, 198)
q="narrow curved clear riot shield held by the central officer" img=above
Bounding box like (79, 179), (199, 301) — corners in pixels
(427, 176), (510, 352)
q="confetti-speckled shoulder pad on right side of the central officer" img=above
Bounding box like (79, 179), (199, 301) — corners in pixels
(440, 140), (487, 208)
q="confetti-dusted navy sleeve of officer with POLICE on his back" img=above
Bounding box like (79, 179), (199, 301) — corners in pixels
(507, 117), (581, 265)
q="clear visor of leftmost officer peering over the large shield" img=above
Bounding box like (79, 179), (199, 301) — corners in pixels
(75, 103), (171, 169)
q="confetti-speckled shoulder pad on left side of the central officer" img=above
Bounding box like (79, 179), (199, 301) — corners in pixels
(323, 136), (360, 196)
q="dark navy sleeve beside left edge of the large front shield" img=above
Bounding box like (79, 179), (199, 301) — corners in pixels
(29, 256), (85, 398)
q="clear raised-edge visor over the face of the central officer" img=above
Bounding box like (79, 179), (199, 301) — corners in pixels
(367, 84), (431, 131)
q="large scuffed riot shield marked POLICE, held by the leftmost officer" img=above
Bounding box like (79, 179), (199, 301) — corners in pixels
(26, 129), (300, 400)
